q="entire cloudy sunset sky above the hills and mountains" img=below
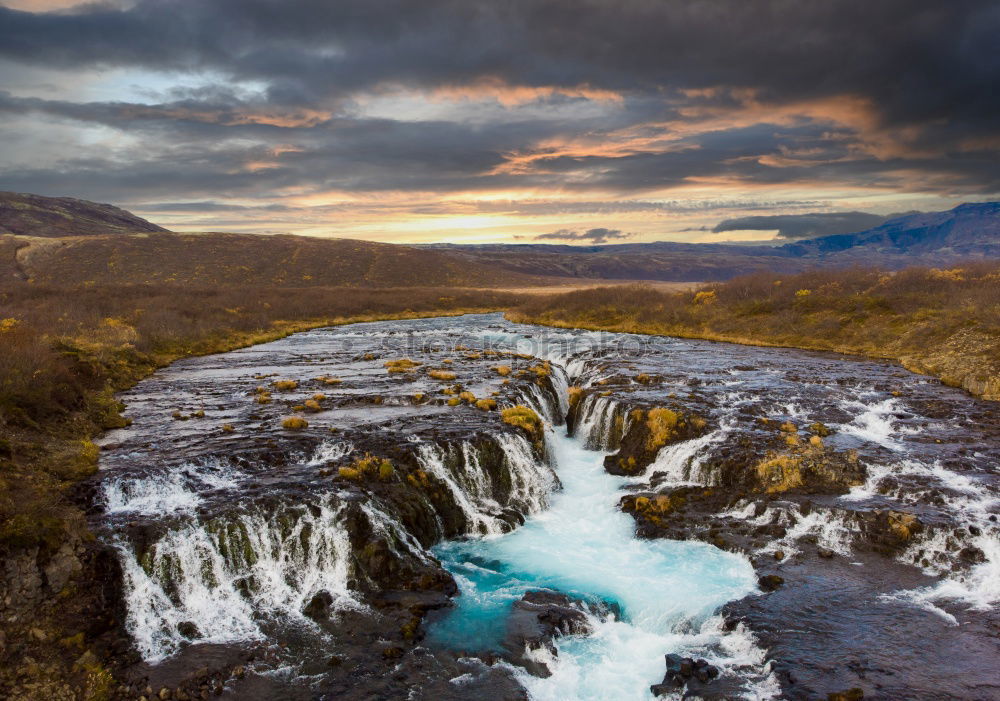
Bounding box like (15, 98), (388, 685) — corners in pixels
(0, 0), (1000, 244)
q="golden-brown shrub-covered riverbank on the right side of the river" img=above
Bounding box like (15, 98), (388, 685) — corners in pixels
(508, 263), (1000, 400)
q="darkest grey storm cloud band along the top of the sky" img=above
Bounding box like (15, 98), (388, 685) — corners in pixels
(0, 0), (1000, 133)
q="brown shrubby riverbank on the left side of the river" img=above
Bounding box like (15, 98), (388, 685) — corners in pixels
(0, 285), (521, 699)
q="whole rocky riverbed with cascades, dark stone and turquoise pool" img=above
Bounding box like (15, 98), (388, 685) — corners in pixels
(85, 315), (1000, 699)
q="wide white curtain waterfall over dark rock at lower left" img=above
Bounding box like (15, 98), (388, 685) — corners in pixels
(115, 498), (359, 662)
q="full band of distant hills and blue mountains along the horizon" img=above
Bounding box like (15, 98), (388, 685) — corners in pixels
(0, 193), (1000, 287)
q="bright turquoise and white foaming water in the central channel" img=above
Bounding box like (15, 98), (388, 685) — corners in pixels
(428, 431), (756, 699)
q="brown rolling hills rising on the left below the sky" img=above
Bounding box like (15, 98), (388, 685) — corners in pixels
(0, 193), (551, 288)
